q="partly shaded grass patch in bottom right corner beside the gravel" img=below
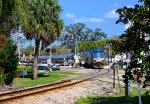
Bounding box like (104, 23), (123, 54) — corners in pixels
(75, 88), (150, 104)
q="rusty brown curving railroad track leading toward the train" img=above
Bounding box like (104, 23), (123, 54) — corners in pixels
(0, 69), (110, 102)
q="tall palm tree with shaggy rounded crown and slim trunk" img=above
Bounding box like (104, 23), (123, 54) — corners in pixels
(15, 0), (63, 79)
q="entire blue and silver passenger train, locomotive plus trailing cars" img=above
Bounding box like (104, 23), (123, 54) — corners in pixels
(23, 48), (105, 68)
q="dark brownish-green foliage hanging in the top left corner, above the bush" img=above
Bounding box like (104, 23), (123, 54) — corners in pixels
(0, 0), (16, 37)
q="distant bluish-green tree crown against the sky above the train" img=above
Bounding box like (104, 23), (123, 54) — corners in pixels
(60, 23), (107, 51)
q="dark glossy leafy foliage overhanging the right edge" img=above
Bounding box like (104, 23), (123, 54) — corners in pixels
(116, 0), (150, 87)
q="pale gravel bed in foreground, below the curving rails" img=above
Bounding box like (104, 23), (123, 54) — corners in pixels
(3, 78), (112, 104)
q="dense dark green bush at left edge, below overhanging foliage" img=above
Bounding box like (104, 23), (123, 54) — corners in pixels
(0, 40), (18, 85)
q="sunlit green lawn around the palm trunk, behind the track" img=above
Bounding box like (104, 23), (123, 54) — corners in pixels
(13, 71), (79, 87)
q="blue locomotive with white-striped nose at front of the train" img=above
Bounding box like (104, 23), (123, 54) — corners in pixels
(80, 48), (105, 68)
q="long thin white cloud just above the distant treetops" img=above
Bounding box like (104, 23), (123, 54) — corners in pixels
(73, 17), (104, 23)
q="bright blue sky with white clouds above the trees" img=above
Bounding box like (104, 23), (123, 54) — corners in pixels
(59, 0), (138, 37)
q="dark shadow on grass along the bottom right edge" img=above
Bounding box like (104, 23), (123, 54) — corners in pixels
(89, 95), (150, 104)
